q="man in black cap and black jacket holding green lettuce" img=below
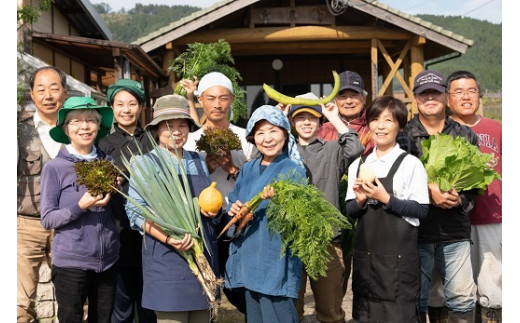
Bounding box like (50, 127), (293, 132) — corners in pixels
(404, 70), (478, 322)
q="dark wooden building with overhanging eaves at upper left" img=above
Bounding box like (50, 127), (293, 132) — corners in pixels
(18, 0), (168, 121)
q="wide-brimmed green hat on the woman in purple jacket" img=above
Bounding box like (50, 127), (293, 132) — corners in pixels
(49, 96), (114, 144)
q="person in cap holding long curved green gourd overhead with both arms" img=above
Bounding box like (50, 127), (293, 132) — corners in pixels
(278, 93), (364, 323)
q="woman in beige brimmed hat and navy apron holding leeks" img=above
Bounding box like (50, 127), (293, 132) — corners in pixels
(126, 94), (221, 323)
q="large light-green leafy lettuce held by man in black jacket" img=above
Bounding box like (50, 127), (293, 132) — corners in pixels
(421, 133), (501, 192)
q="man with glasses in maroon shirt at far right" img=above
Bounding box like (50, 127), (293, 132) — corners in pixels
(446, 71), (502, 322)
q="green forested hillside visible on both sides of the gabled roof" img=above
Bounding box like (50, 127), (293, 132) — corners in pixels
(94, 3), (502, 93)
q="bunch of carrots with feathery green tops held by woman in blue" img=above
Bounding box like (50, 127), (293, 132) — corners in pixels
(217, 174), (352, 279)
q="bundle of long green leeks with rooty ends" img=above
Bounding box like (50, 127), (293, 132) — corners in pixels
(120, 132), (223, 309)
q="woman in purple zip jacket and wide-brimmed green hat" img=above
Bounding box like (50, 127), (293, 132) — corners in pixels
(41, 97), (119, 323)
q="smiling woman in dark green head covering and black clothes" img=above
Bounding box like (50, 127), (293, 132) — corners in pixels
(98, 79), (157, 323)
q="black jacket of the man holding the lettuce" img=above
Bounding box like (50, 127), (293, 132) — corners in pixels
(404, 114), (478, 243)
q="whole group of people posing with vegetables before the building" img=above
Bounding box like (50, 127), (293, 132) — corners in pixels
(17, 66), (502, 323)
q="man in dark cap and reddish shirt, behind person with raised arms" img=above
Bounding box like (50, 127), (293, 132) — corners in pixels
(318, 71), (374, 154)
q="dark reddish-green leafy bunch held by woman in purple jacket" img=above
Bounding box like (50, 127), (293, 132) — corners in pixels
(74, 159), (119, 196)
